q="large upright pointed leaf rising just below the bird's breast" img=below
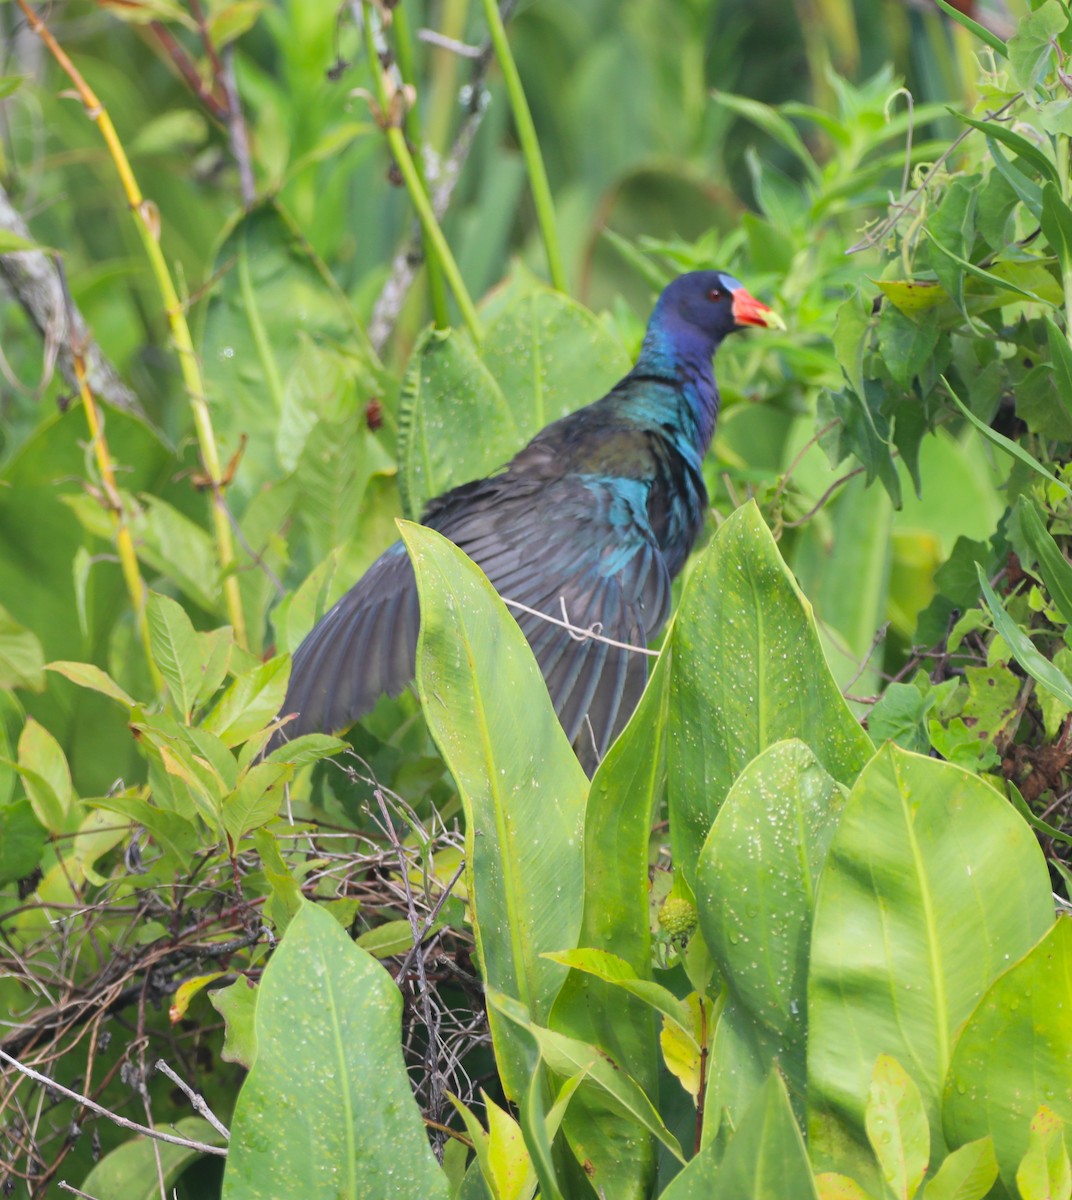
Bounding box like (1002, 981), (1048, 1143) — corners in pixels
(667, 502), (874, 881)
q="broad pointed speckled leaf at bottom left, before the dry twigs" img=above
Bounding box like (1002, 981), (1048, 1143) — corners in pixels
(222, 902), (447, 1200)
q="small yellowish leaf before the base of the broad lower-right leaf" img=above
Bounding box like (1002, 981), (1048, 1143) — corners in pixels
(864, 1054), (930, 1200)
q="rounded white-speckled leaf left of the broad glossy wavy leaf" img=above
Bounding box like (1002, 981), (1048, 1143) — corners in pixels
(696, 740), (844, 1140)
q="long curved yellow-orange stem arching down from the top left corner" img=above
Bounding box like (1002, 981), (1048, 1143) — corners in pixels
(17, 0), (246, 647)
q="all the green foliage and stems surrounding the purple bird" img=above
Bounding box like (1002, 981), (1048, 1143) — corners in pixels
(0, 0), (1072, 1200)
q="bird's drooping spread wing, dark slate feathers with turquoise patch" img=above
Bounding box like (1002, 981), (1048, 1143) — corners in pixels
(283, 474), (670, 769)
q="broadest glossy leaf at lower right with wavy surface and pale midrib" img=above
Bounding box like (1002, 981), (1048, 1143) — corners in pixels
(808, 745), (1053, 1186)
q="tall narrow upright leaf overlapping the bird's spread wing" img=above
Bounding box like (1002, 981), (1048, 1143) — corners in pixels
(400, 522), (588, 1099)
